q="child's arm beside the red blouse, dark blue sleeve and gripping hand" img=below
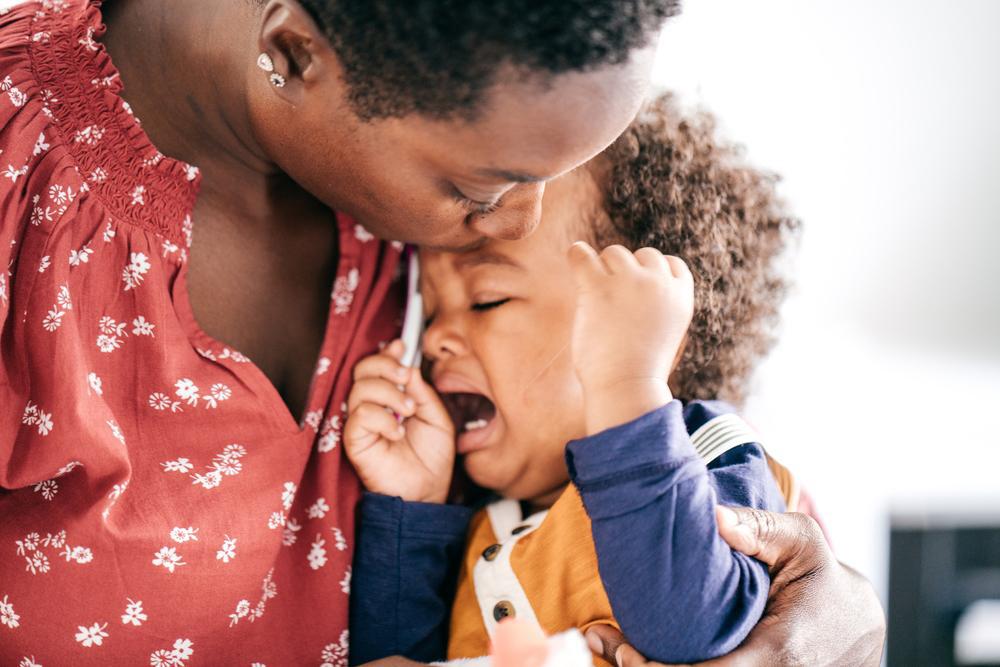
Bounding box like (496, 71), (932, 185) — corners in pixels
(344, 341), (460, 664)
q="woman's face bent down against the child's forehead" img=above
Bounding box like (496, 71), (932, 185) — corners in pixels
(255, 49), (653, 249)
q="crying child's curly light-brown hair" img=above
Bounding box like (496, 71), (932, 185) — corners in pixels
(591, 93), (799, 405)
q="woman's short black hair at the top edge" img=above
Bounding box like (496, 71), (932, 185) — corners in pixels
(299, 0), (680, 120)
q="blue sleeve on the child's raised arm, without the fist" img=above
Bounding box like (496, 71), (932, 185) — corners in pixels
(567, 401), (784, 663)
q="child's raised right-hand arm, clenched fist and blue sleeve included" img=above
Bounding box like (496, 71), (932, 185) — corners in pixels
(567, 243), (773, 662)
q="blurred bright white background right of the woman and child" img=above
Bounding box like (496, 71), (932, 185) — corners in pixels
(655, 0), (1000, 665)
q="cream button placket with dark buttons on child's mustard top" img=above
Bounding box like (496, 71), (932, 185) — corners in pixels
(472, 500), (548, 639)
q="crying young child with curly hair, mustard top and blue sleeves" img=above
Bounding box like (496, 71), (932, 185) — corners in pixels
(344, 96), (796, 664)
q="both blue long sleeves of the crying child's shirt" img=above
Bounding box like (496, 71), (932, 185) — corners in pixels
(351, 401), (784, 663)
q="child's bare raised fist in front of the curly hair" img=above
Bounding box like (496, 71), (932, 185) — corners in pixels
(569, 242), (694, 434)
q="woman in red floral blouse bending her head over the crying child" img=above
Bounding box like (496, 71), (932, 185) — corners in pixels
(0, 0), (884, 665)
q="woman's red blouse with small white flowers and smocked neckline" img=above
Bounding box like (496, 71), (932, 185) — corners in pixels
(0, 0), (401, 667)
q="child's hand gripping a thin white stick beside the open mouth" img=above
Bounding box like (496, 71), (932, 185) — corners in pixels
(344, 340), (455, 503)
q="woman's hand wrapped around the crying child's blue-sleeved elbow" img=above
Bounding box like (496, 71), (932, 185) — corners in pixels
(587, 507), (885, 667)
